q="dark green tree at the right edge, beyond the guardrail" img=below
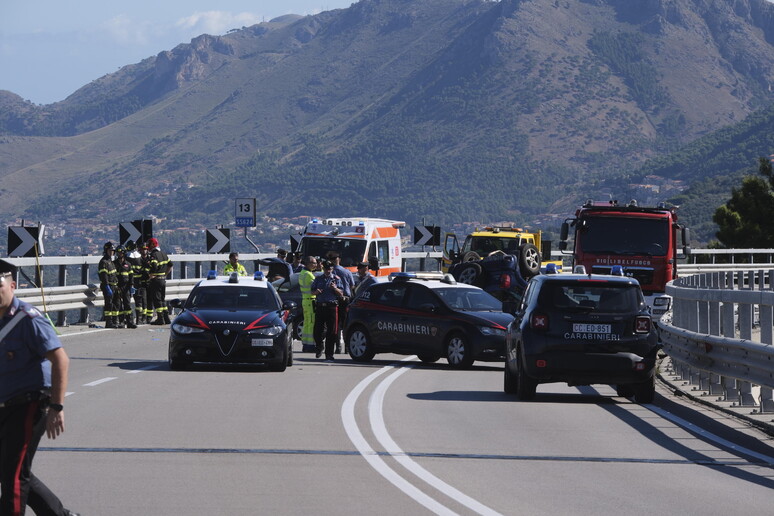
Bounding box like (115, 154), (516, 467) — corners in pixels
(712, 158), (774, 249)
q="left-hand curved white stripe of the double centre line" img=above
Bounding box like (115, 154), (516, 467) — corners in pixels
(341, 357), (457, 516)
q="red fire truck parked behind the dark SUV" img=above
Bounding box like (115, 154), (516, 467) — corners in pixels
(559, 200), (691, 317)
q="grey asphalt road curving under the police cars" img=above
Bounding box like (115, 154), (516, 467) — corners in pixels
(34, 326), (774, 516)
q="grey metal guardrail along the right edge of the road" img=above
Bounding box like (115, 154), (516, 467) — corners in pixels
(659, 268), (774, 413)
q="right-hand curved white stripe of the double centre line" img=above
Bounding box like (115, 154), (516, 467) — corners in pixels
(368, 357), (500, 516)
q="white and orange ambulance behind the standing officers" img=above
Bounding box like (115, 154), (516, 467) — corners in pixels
(298, 218), (406, 276)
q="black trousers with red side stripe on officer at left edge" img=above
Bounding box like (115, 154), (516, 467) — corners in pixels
(0, 401), (65, 516)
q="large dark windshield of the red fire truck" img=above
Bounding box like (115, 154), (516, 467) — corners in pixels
(580, 217), (669, 256)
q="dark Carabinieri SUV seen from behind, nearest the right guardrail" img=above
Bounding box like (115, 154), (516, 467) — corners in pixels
(503, 266), (660, 403)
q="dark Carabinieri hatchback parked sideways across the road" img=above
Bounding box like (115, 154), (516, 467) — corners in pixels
(344, 273), (513, 368)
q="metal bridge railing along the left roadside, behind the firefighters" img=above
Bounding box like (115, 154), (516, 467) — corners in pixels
(7, 251), (441, 326)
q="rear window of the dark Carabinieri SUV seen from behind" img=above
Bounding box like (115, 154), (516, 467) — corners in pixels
(538, 281), (644, 313)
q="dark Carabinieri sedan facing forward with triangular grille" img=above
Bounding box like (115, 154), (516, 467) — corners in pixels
(169, 271), (296, 371)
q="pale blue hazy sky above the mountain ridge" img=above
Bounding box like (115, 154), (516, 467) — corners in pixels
(0, 0), (356, 104)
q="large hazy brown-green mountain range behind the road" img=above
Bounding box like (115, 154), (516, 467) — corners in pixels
(0, 0), (774, 237)
